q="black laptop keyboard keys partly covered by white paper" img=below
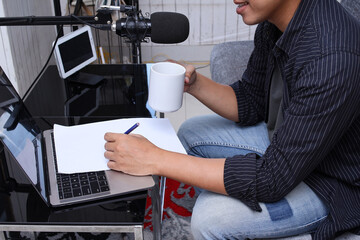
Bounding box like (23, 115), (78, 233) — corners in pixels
(56, 171), (110, 199)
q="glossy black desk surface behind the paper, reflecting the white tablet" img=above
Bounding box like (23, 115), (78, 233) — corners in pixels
(25, 64), (151, 126)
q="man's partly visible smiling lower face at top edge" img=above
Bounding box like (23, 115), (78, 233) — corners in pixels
(233, 0), (300, 27)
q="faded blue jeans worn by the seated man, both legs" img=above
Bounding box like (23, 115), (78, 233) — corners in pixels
(178, 115), (328, 240)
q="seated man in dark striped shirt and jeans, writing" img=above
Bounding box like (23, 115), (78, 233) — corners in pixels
(105, 0), (360, 239)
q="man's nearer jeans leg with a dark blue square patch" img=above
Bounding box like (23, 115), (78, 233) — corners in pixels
(191, 182), (328, 240)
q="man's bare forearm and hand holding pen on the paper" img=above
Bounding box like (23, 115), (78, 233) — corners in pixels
(105, 133), (226, 194)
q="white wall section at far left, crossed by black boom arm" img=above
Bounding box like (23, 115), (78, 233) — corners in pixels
(0, 0), (56, 95)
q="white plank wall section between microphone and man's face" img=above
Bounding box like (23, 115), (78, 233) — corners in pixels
(139, 0), (255, 45)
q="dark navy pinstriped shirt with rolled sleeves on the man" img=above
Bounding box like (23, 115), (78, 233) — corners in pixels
(224, 0), (360, 239)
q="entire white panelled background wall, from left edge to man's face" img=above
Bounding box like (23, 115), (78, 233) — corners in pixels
(0, 0), (255, 94)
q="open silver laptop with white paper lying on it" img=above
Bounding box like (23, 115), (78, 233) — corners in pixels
(0, 67), (154, 207)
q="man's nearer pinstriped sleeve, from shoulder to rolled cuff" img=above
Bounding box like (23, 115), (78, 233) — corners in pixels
(224, 51), (360, 206)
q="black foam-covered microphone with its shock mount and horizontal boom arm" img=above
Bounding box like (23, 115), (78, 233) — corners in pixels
(0, 5), (189, 63)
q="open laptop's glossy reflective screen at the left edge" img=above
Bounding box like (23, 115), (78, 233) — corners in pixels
(0, 67), (46, 202)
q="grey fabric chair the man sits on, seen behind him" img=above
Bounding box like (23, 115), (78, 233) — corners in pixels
(210, 0), (360, 240)
